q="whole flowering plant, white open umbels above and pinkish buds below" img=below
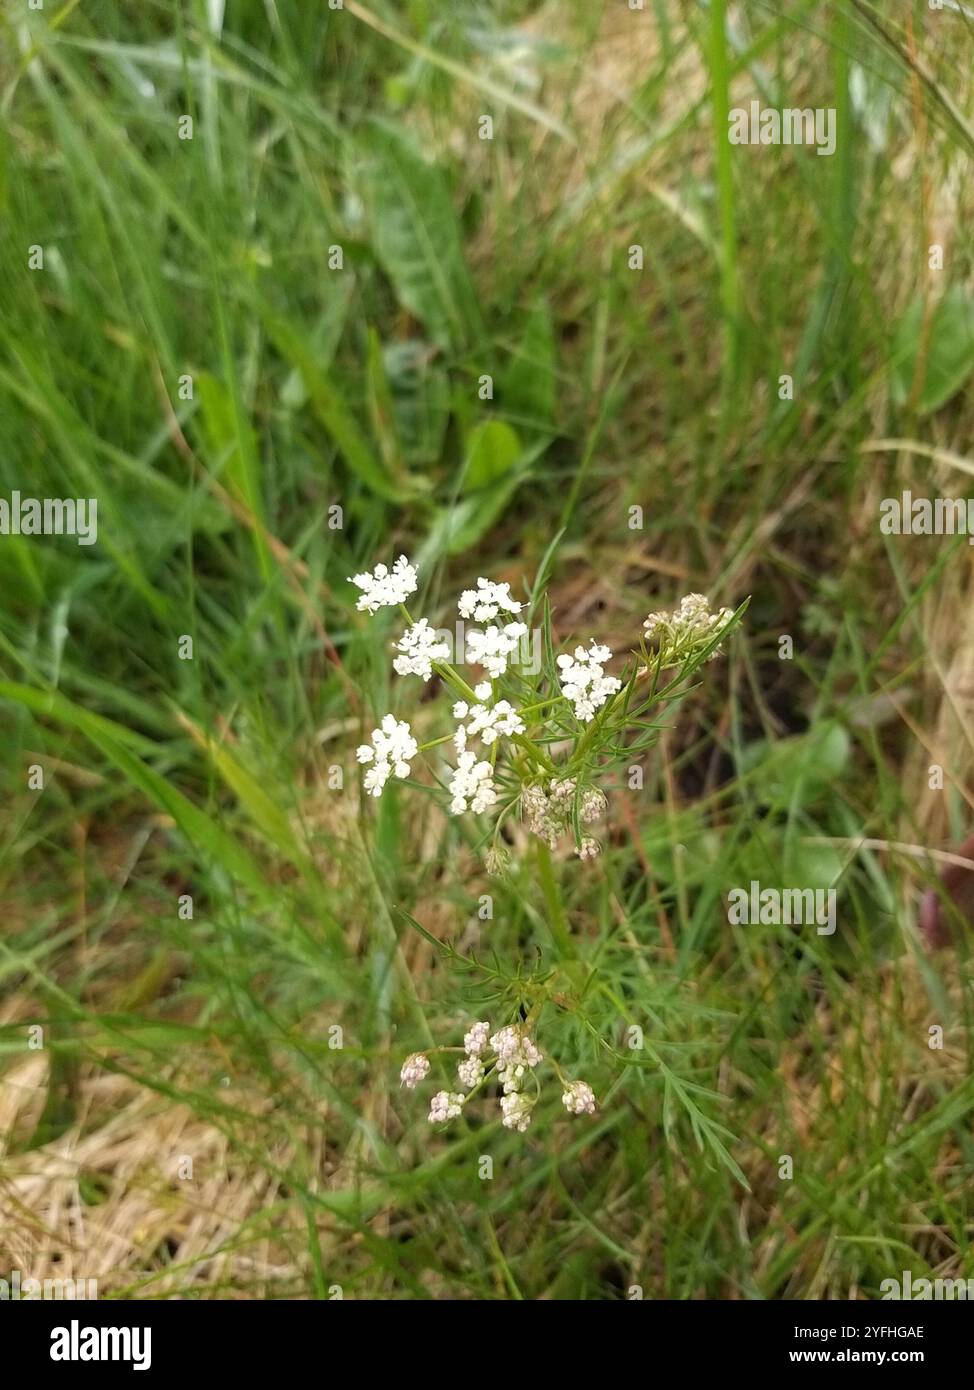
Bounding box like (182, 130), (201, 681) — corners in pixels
(361, 556), (736, 1134)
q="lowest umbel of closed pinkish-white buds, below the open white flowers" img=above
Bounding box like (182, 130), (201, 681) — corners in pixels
(400, 1022), (595, 1134)
